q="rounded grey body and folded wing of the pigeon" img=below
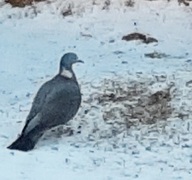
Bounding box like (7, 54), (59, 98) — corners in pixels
(22, 79), (81, 133)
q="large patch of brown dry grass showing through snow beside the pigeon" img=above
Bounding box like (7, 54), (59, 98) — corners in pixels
(94, 79), (172, 128)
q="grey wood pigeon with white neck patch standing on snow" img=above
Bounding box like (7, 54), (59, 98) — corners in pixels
(7, 53), (83, 151)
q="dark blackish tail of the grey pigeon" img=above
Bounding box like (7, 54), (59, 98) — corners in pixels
(7, 135), (40, 151)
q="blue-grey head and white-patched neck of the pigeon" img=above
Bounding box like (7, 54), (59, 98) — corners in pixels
(60, 53), (83, 78)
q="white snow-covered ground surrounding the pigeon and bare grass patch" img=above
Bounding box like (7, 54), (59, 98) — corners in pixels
(0, 0), (192, 180)
